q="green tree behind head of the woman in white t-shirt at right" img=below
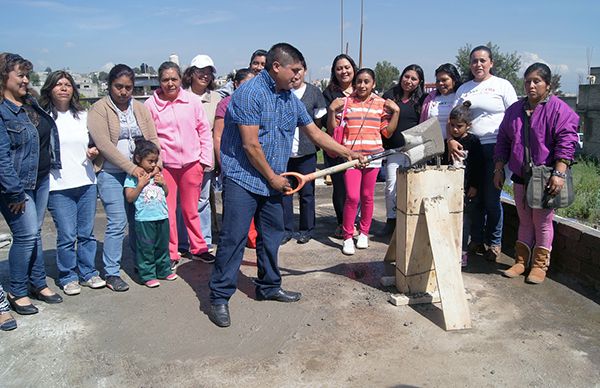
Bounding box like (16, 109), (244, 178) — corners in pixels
(455, 42), (523, 94)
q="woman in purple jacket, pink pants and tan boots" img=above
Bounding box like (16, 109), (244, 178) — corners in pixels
(494, 63), (579, 284)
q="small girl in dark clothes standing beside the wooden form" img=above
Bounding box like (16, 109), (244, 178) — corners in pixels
(446, 101), (483, 267)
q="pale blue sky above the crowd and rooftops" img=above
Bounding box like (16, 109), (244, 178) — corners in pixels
(0, 0), (600, 93)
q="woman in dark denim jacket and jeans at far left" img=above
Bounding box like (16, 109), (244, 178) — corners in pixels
(0, 53), (62, 315)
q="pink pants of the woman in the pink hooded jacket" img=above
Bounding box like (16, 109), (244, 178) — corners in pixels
(163, 162), (208, 260)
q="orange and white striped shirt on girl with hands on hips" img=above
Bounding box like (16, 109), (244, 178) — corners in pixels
(337, 94), (390, 155)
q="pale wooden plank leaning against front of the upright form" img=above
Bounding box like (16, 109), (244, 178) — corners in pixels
(423, 196), (471, 330)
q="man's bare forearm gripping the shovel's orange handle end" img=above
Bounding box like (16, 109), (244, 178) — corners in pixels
(238, 124), (290, 193)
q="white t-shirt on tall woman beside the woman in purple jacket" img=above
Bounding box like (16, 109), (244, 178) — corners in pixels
(454, 76), (517, 144)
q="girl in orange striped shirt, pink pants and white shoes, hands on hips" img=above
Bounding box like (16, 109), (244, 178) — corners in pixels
(328, 69), (400, 255)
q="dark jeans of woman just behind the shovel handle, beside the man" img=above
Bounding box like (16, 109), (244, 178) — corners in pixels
(283, 154), (317, 237)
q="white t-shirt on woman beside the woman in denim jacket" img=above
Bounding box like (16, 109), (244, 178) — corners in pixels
(50, 112), (96, 191)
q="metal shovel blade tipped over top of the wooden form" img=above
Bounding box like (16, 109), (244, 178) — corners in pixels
(402, 117), (444, 168)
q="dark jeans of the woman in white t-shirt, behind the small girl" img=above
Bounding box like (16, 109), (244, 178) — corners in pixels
(471, 144), (502, 246)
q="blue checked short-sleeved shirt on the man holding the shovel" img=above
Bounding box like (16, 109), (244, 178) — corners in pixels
(221, 70), (312, 196)
